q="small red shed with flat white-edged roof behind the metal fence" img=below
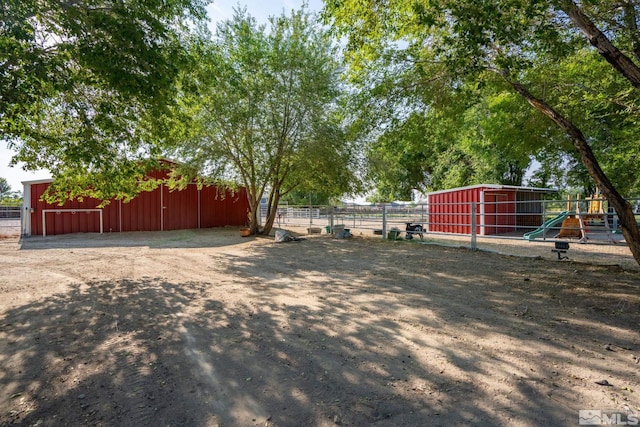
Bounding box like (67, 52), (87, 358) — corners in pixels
(427, 184), (555, 235)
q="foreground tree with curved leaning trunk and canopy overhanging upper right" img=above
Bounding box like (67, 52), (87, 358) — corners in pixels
(326, 0), (640, 263)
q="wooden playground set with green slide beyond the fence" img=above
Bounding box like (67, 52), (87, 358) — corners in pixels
(523, 190), (620, 244)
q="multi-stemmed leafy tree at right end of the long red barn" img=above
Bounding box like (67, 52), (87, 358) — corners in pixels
(168, 9), (354, 234)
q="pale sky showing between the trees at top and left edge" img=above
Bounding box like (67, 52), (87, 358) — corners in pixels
(0, 0), (322, 191)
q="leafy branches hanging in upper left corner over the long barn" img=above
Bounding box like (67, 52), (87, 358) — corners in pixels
(0, 0), (207, 200)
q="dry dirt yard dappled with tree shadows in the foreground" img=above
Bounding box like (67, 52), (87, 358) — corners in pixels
(0, 229), (640, 426)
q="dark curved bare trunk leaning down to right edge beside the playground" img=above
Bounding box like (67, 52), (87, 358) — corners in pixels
(502, 73), (640, 264)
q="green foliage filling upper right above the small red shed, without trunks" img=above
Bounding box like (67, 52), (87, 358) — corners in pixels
(325, 0), (640, 198)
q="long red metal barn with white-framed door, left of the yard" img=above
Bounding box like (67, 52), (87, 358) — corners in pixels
(22, 166), (249, 236)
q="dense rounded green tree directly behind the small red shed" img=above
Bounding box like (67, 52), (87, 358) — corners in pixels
(368, 85), (542, 200)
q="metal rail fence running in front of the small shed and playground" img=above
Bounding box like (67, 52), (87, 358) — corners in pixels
(264, 199), (640, 269)
